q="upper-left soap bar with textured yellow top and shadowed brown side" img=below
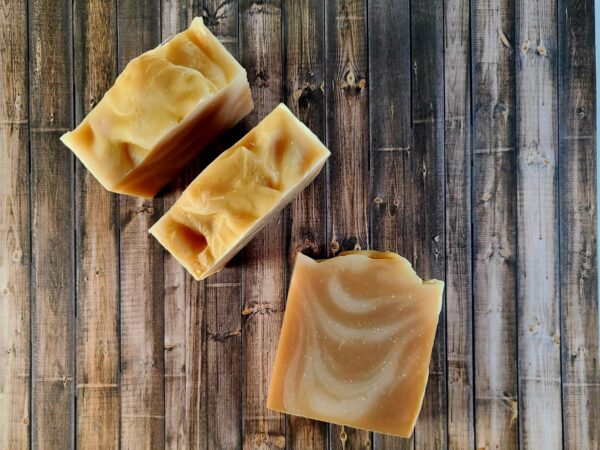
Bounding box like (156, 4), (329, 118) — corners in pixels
(61, 18), (254, 197)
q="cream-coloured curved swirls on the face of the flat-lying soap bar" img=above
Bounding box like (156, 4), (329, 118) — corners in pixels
(292, 276), (418, 420)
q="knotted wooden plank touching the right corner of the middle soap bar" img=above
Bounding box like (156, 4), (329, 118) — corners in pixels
(325, 0), (372, 450)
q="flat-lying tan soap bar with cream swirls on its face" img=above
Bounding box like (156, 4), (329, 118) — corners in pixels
(267, 251), (444, 437)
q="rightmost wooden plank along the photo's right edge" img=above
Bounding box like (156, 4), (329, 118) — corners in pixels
(558, 0), (600, 449)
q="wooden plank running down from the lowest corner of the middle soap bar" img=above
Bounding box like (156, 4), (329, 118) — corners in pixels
(161, 4), (210, 449)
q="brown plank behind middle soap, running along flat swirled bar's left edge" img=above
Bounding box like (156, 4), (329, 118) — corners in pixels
(239, 0), (286, 449)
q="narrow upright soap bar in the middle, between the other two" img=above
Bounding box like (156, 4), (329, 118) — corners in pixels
(150, 104), (330, 280)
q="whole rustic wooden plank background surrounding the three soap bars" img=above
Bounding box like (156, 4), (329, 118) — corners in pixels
(0, 0), (600, 450)
